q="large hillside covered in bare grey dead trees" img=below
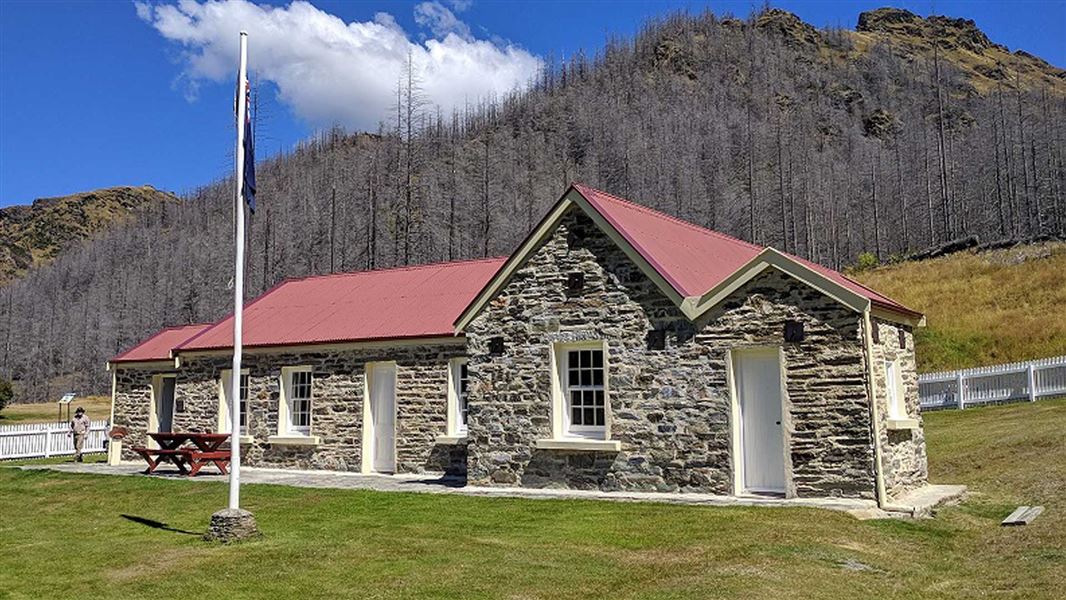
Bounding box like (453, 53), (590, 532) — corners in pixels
(0, 5), (1066, 398)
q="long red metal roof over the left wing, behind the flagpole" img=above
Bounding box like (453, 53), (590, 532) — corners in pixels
(177, 258), (506, 351)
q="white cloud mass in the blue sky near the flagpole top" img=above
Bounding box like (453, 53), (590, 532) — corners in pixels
(134, 0), (542, 129)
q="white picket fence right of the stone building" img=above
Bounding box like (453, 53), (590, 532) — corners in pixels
(918, 356), (1066, 410)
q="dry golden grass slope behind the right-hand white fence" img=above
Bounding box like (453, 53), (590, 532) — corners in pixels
(854, 242), (1066, 372)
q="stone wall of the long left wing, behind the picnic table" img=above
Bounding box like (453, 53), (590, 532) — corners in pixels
(108, 343), (466, 475)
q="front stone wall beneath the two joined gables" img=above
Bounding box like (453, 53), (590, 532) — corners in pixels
(467, 209), (875, 498)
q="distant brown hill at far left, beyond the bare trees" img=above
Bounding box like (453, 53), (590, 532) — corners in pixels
(0, 185), (177, 285)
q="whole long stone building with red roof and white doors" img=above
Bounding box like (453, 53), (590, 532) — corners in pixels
(110, 184), (926, 503)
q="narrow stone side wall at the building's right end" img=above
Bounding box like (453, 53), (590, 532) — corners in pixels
(871, 319), (928, 498)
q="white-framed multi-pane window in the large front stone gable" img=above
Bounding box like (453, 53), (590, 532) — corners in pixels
(555, 342), (608, 439)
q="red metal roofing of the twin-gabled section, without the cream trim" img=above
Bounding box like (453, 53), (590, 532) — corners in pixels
(574, 183), (919, 314)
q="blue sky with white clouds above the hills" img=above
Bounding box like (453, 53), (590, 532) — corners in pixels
(0, 0), (1066, 206)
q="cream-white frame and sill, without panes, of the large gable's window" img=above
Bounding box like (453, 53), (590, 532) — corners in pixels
(552, 340), (611, 440)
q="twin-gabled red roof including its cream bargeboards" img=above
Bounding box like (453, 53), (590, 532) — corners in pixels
(455, 183), (922, 330)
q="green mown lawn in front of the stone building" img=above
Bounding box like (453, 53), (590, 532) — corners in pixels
(0, 401), (1066, 599)
